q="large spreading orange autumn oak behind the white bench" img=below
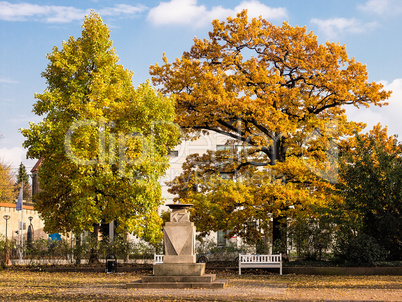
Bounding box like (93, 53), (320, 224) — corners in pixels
(150, 11), (390, 253)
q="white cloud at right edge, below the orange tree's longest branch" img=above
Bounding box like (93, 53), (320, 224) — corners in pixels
(346, 79), (402, 138)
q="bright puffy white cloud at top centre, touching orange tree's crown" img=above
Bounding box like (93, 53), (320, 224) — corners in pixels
(147, 0), (287, 27)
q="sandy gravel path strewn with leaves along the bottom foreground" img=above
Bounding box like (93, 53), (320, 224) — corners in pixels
(63, 279), (402, 301)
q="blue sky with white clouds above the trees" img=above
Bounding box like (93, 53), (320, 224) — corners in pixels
(0, 0), (402, 169)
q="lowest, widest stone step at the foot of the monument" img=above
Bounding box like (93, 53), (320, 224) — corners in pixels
(126, 279), (229, 289)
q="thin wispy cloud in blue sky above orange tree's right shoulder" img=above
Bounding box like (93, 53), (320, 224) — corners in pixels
(310, 18), (377, 38)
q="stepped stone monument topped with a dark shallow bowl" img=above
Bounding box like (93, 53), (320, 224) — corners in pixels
(127, 203), (228, 288)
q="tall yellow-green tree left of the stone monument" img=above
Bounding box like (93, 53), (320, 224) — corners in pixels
(21, 12), (179, 258)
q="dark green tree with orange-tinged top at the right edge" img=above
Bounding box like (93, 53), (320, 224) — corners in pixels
(338, 124), (402, 260)
